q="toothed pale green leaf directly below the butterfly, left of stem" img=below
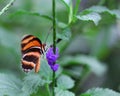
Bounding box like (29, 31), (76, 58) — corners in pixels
(22, 73), (45, 96)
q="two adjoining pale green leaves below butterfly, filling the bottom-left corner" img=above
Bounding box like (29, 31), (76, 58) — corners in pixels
(0, 73), (45, 96)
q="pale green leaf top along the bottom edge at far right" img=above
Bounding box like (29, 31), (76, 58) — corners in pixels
(80, 88), (120, 96)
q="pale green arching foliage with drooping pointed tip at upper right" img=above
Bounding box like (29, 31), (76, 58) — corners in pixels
(76, 6), (120, 25)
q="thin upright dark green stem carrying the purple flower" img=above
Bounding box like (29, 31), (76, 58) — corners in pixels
(52, 0), (56, 96)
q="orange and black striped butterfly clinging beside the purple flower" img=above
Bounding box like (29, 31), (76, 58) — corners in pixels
(21, 35), (45, 72)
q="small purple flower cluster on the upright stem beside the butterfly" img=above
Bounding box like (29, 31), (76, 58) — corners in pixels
(46, 47), (59, 71)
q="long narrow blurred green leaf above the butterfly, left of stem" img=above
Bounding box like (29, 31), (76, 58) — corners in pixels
(10, 10), (52, 20)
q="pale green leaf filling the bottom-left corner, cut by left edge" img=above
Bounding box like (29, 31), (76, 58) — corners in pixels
(0, 73), (22, 96)
